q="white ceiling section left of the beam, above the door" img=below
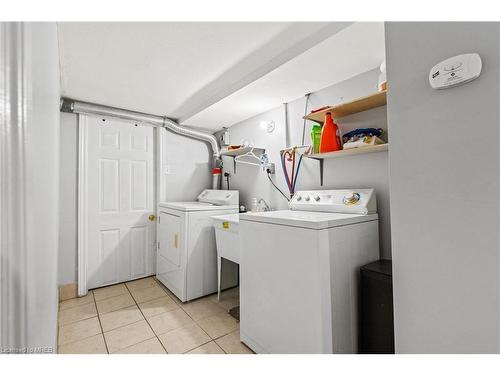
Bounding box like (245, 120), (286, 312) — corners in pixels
(58, 22), (342, 118)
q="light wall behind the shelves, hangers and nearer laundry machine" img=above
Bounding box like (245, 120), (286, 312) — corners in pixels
(223, 69), (391, 258)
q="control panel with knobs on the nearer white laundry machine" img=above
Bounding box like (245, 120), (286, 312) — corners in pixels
(289, 189), (377, 215)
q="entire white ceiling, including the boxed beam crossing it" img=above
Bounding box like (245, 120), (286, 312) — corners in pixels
(58, 22), (384, 130)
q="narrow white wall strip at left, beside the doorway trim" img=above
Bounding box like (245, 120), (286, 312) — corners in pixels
(26, 23), (59, 347)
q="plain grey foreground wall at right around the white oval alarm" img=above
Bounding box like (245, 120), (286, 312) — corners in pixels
(386, 23), (500, 353)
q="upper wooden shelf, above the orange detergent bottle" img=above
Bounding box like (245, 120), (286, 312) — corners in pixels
(303, 90), (387, 124)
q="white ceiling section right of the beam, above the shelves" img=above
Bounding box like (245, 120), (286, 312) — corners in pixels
(185, 22), (385, 130)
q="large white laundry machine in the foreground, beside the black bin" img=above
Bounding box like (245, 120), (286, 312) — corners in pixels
(240, 189), (379, 354)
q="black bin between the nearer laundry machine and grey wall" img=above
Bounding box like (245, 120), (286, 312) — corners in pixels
(359, 260), (394, 354)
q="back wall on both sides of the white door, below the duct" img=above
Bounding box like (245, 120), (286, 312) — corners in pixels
(58, 113), (212, 285)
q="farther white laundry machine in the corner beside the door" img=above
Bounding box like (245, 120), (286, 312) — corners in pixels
(156, 189), (239, 302)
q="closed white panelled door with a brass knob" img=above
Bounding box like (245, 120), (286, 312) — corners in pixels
(79, 116), (156, 291)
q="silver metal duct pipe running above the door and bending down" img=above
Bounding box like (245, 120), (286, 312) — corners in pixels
(60, 98), (221, 160)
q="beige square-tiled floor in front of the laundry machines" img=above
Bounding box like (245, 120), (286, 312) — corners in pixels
(58, 277), (252, 354)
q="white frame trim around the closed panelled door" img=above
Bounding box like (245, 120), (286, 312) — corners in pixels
(77, 113), (161, 297)
